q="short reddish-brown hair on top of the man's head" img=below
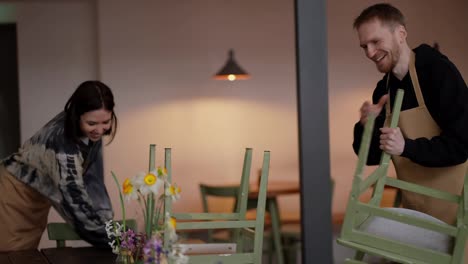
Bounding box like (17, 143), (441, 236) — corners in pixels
(353, 3), (406, 29)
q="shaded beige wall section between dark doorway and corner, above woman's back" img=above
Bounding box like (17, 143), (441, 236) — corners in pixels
(7, 1), (98, 247)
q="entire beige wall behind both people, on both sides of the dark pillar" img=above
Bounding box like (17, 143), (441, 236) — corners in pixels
(0, 0), (468, 250)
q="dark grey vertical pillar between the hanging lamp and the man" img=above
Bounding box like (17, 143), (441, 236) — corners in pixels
(295, 0), (333, 264)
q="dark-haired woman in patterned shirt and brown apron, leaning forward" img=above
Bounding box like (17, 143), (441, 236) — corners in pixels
(0, 81), (117, 251)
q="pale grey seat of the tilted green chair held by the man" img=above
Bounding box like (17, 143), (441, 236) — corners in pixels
(358, 208), (452, 253)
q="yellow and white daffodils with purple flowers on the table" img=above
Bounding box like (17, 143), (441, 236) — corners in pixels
(106, 168), (188, 264)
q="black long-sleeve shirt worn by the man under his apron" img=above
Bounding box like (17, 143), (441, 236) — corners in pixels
(353, 44), (468, 167)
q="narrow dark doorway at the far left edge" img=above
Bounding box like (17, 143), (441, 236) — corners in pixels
(0, 24), (20, 159)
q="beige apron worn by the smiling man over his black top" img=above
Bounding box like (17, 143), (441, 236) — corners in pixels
(386, 52), (468, 263)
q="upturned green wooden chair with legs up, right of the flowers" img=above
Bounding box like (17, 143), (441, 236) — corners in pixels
(161, 148), (270, 264)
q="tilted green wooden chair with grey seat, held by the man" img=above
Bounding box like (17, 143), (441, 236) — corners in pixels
(337, 90), (468, 264)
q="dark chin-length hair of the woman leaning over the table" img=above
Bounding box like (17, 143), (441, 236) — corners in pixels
(65, 81), (117, 143)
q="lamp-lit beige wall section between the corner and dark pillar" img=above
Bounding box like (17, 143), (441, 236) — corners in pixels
(99, 0), (299, 234)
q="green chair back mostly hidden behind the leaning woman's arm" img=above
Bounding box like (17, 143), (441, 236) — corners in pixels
(47, 219), (137, 247)
